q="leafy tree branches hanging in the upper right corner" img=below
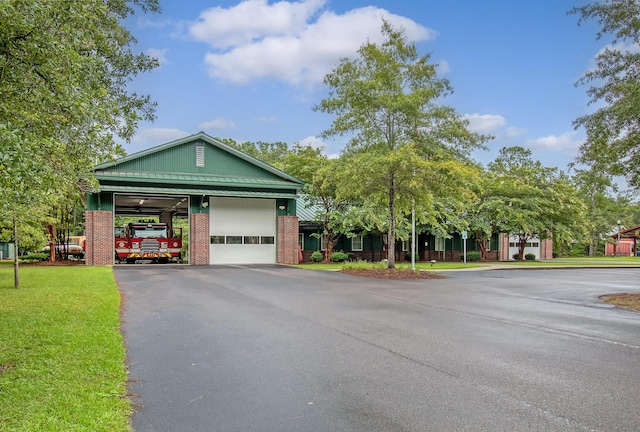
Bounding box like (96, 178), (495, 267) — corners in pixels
(569, 0), (640, 186)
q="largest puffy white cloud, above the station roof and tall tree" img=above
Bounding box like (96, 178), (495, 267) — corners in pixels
(189, 0), (435, 86)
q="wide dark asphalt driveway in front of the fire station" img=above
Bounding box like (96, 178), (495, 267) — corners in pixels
(114, 266), (640, 432)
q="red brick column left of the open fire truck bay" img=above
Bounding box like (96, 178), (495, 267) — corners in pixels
(85, 210), (115, 265)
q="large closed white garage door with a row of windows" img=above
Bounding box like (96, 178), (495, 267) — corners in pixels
(209, 197), (276, 264)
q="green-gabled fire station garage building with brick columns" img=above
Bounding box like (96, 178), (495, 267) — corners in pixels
(86, 132), (303, 265)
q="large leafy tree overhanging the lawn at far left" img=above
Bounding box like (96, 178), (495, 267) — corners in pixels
(0, 0), (159, 286)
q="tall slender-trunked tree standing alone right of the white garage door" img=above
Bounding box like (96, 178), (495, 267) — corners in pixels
(314, 21), (487, 268)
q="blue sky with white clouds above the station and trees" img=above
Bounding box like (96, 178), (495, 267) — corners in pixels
(124, 0), (605, 169)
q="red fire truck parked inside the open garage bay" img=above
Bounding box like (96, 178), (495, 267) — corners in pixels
(115, 221), (182, 264)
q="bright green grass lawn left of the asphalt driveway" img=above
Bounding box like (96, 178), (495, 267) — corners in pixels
(0, 266), (131, 431)
